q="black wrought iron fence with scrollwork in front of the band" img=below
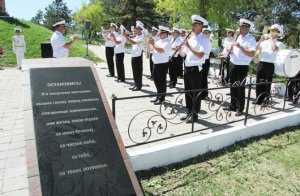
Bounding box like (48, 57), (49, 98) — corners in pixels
(112, 79), (300, 148)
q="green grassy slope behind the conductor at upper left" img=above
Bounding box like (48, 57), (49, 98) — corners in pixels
(0, 19), (100, 67)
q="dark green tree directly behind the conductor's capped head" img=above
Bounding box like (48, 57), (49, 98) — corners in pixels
(43, 0), (72, 29)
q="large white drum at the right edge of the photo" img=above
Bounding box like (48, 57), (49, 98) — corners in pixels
(275, 49), (300, 78)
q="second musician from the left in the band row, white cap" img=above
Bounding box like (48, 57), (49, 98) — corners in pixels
(111, 25), (126, 82)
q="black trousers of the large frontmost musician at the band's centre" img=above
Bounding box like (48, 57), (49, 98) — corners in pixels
(184, 66), (202, 113)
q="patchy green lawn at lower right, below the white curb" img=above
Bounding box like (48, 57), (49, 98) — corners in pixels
(138, 128), (300, 196)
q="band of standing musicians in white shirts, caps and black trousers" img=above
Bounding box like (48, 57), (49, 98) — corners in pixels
(102, 15), (300, 122)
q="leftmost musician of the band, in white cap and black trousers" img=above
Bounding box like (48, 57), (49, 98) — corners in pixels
(102, 23), (118, 77)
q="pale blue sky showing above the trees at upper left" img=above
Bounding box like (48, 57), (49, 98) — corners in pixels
(5, 0), (89, 20)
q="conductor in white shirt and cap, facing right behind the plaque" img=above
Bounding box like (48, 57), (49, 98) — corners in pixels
(51, 20), (78, 58)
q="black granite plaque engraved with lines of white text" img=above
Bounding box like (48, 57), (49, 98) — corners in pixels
(30, 67), (136, 196)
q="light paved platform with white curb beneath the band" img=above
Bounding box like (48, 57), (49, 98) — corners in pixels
(90, 46), (300, 170)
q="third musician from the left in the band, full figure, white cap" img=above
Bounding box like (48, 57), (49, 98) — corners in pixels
(126, 21), (145, 91)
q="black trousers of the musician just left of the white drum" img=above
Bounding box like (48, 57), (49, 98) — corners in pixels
(256, 62), (275, 104)
